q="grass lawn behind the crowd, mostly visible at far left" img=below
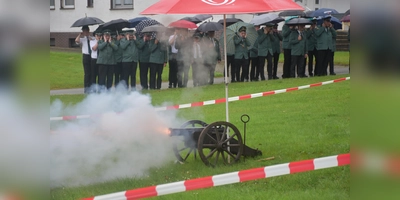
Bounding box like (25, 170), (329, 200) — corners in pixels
(50, 51), (349, 90)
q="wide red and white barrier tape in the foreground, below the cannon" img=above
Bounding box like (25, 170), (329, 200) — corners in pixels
(83, 154), (350, 200)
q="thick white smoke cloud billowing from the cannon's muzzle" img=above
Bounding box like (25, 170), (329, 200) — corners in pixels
(50, 91), (180, 187)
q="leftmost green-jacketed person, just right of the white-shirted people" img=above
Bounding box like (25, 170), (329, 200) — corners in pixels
(97, 30), (118, 92)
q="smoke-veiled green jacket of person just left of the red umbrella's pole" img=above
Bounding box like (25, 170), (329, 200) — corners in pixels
(201, 37), (221, 65)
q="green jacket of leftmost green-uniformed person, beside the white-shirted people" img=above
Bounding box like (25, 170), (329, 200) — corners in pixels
(97, 40), (118, 65)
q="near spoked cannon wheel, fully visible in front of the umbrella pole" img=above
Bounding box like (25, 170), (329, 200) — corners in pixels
(197, 121), (244, 167)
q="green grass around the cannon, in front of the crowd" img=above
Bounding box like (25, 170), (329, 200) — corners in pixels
(50, 75), (350, 200)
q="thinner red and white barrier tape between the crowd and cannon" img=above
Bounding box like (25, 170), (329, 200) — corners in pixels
(50, 77), (350, 121)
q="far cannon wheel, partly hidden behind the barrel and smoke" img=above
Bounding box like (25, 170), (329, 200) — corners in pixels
(173, 120), (208, 162)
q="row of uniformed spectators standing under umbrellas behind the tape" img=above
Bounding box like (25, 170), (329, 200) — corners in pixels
(75, 17), (336, 93)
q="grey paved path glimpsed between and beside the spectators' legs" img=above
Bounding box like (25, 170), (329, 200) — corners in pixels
(50, 63), (349, 95)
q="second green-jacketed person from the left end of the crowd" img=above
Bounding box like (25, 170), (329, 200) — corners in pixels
(119, 30), (139, 91)
